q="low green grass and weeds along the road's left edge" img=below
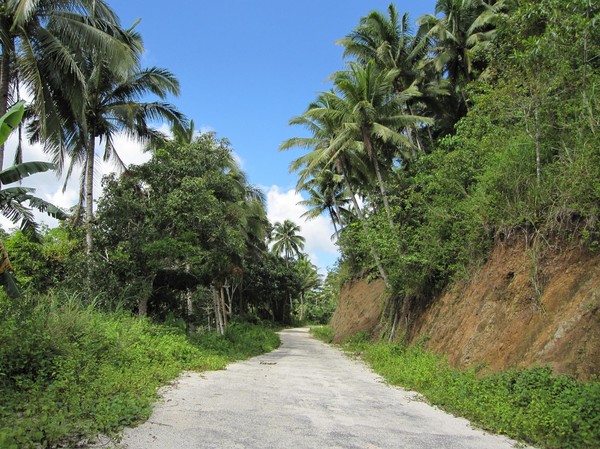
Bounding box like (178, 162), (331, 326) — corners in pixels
(0, 295), (279, 449)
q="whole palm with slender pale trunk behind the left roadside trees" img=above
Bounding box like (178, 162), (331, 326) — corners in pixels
(60, 53), (184, 254)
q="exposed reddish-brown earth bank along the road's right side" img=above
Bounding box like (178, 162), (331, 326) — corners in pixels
(332, 239), (600, 380)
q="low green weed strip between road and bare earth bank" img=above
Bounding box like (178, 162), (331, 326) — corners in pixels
(313, 328), (600, 449)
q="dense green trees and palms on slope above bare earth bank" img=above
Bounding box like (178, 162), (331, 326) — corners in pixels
(281, 0), (600, 334)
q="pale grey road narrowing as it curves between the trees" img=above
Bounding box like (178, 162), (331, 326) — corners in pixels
(120, 329), (528, 449)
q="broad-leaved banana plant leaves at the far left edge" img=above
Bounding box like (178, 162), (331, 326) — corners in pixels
(0, 101), (67, 298)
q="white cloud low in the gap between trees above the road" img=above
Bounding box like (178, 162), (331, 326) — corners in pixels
(267, 185), (338, 273)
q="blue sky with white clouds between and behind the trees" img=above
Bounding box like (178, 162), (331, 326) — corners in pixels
(5, 0), (435, 271)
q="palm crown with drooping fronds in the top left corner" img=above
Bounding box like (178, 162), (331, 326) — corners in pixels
(0, 0), (137, 169)
